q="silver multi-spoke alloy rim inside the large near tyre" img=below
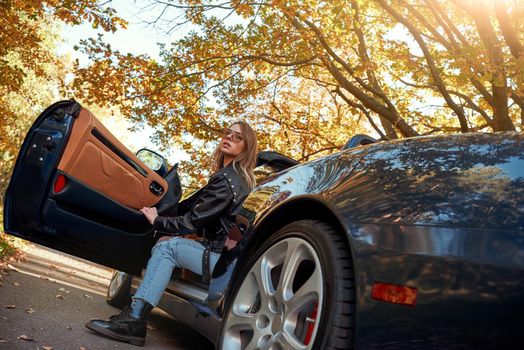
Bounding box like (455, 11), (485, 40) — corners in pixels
(222, 237), (324, 350)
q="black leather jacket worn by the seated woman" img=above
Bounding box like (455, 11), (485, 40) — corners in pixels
(153, 164), (250, 252)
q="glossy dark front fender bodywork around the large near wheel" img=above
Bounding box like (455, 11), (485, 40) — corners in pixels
(200, 133), (524, 348)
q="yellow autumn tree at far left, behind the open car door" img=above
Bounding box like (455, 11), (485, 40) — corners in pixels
(0, 0), (125, 219)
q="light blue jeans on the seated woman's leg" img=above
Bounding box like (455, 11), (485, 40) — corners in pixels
(134, 237), (220, 306)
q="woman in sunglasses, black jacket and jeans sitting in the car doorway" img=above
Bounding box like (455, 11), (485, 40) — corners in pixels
(86, 121), (257, 346)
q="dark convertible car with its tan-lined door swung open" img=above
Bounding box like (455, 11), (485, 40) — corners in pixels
(4, 101), (524, 350)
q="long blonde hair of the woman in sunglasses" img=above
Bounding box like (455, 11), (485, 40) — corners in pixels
(211, 120), (258, 188)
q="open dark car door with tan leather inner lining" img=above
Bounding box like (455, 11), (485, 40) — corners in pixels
(4, 101), (168, 274)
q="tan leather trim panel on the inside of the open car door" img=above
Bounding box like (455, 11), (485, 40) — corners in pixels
(58, 109), (167, 209)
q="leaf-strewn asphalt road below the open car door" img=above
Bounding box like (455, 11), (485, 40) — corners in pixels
(0, 244), (213, 350)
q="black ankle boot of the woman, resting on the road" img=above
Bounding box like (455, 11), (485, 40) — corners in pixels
(86, 299), (153, 346)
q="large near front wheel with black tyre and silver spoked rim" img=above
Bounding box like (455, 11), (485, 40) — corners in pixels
(219, 220), (355, 350)
